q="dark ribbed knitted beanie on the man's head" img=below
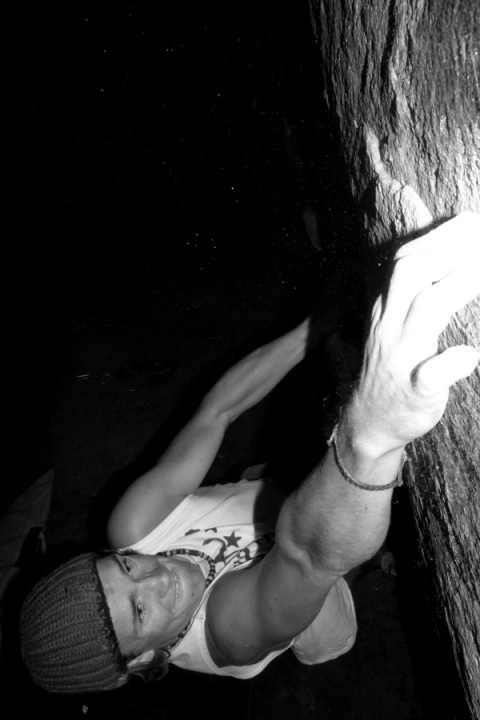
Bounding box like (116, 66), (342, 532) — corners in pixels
(20, 553), (128, 693)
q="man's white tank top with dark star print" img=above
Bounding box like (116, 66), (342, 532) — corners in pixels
(129, 479), (356, 679)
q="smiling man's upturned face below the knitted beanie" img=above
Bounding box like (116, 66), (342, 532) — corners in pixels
(97, 553), (205, 657)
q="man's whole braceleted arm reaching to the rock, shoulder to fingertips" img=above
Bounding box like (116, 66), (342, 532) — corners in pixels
(207, 214), (480, 666)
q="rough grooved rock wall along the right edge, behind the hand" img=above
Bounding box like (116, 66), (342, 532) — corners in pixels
(310, 0), (480, 718)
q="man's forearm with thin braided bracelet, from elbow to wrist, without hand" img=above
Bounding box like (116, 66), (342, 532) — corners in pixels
(277, 413), (403, 575)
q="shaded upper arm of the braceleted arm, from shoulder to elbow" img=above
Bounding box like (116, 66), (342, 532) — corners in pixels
(207, 546), (338, 665)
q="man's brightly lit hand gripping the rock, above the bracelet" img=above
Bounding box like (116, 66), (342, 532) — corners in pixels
(346, 213), (480, 455)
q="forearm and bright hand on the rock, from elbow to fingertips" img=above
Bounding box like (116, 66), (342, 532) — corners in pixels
(277, 213), (480, 575)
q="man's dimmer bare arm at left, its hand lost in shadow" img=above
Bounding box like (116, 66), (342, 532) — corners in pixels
(107, 318), (309, 547)
